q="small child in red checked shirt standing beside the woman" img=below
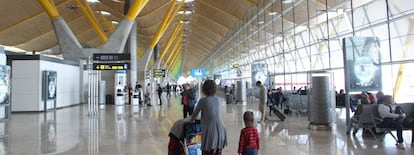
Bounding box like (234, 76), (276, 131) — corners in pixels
(237, 111), (260, 155)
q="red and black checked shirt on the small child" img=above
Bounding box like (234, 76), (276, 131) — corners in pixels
(237, 127), (260, 153)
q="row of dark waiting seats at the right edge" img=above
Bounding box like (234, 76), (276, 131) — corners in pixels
(351, 103), (414, 144)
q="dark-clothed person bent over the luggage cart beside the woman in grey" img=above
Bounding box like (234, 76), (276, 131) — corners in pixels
(168, 118), (189, 155)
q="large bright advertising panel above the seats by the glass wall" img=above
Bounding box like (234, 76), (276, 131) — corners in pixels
(343, 37), (382, 91)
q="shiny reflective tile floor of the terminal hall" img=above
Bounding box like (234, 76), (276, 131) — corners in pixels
(0, 92), (414, 155)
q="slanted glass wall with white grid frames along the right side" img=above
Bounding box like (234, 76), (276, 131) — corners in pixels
(208, 0), (414, 102)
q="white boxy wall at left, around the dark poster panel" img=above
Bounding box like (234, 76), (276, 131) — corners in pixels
(11, 60), (80, 112)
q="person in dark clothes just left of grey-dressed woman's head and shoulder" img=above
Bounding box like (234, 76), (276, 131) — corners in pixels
(181, 83), (195, 118)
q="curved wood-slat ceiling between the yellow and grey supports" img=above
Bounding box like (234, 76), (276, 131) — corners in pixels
(0, 0), (348, 74)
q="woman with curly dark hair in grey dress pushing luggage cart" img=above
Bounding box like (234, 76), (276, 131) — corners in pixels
(191, 80), (227, 155)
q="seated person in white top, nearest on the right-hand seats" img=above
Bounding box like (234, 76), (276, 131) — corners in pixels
(378, 95), (405, 149)
